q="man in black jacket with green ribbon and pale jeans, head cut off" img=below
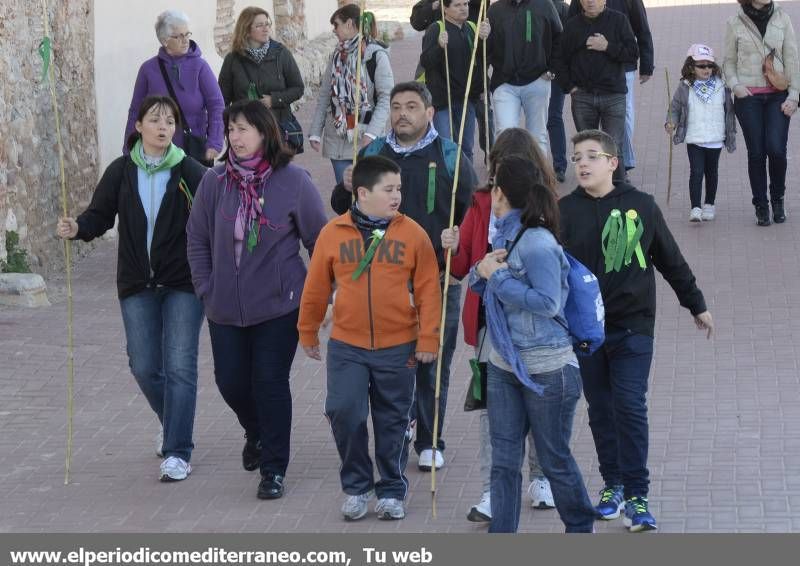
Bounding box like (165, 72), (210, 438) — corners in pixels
(487, 0), (561, 153)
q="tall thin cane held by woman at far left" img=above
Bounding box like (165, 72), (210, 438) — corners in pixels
(39, 0), (75, 485)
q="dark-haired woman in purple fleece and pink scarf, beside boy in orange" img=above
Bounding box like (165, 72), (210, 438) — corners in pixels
(186, 100), (327, 499)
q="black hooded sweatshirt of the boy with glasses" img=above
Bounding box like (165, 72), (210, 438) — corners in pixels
(558, 182), (706, 336)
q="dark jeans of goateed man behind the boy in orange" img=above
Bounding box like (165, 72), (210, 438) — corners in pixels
(414, 284), (461, 454)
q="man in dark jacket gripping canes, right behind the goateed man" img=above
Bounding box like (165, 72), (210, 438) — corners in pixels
(419, 0), (490, 161)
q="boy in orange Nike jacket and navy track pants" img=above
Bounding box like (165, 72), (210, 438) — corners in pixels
(298, 156), (442, 520)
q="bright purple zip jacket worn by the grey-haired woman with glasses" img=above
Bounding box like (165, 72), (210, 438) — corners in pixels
(123, 41), (225, 154)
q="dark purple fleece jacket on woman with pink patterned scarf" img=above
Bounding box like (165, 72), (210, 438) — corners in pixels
(186, 163), (328, 327)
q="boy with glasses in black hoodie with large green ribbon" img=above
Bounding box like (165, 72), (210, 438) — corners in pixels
(559, 130), (714, 532)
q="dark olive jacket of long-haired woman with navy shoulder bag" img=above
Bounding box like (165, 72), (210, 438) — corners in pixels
(219, 40), (305, 122)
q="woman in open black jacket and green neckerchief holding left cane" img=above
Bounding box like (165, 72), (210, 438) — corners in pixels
(57, 96), (206, 482)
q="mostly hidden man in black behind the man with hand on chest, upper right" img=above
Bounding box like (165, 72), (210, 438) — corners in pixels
(569, 0), (655, 169)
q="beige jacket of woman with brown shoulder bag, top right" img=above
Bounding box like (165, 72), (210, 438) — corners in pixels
(722, 4), (800, 102)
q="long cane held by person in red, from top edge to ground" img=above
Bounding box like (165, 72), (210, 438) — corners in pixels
(431, 0), (486, 519)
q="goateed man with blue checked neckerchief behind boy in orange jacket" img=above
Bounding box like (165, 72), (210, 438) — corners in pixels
(331, 81), (478, 471)
